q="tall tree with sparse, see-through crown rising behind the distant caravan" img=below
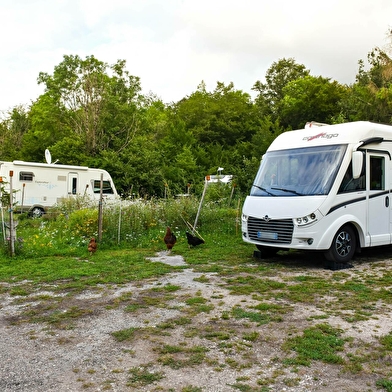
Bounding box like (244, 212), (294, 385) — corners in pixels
(38, 55), (141, 156)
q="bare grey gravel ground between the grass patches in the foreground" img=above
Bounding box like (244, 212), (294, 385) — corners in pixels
(0, 252), (392, 392)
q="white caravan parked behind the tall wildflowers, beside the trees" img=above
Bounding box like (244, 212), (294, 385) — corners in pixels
(0, 161), (118, 217)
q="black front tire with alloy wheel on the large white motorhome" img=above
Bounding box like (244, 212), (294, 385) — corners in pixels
(325, 225), (357, 263)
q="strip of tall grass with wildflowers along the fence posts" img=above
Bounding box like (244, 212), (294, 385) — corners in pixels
(2, 191), (243, 258)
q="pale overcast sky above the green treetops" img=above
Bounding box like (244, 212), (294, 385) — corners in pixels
(0, 0), (392, 111)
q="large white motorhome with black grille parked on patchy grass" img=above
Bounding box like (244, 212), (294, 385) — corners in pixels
(242, 121), (392, 265)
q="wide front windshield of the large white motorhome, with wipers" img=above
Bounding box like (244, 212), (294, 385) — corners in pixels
(250, 145), (347, 197)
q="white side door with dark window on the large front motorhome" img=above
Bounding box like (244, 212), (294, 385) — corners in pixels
(366, 151), (392, 246)
